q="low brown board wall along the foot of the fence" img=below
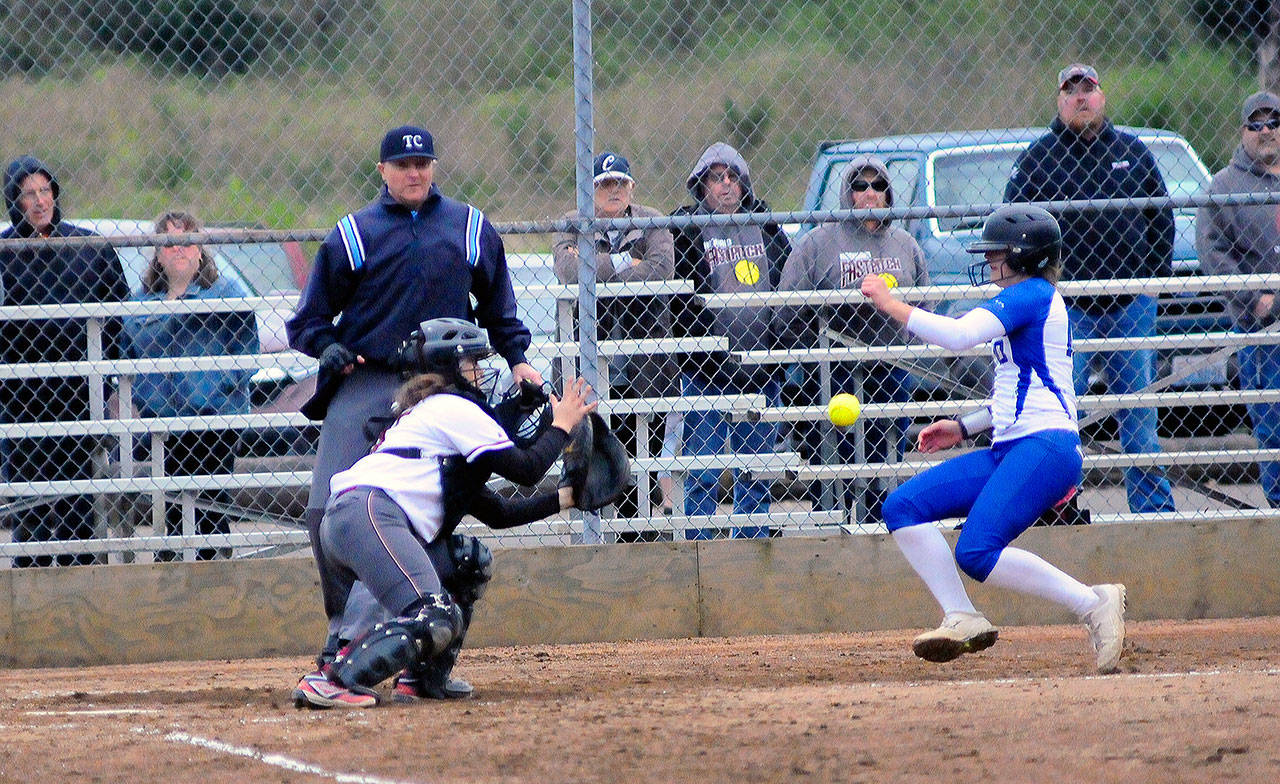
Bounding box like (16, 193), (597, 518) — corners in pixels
(0, 521), (1280, 667)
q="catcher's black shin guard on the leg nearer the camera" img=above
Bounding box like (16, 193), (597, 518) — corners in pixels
(330, 593), (462, 688)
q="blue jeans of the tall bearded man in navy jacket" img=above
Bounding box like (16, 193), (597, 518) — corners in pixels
(1069, 296), (1174, 512)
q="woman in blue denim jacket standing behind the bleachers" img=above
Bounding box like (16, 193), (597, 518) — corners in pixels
(124, 211), (259, 561)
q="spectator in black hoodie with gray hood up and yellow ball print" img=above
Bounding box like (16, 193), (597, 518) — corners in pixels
(672, 142), (791, 537)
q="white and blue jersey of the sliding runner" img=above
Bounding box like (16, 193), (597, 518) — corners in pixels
(979, 278), (1076, 443)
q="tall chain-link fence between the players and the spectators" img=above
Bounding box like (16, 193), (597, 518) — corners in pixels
(0, 0), (1280, 565)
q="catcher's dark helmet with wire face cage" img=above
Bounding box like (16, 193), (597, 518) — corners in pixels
(397, 318), (499, 398)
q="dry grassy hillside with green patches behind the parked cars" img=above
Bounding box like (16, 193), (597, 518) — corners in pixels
(0, 0), (1256, 245)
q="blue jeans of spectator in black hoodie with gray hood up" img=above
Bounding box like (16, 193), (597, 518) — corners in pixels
(681, 374), (778, 538)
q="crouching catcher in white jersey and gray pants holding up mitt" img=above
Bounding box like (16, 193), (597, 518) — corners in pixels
(293, 319), (630, 708)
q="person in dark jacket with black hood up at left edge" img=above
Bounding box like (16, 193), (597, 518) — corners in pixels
(0, 155), (129, 566)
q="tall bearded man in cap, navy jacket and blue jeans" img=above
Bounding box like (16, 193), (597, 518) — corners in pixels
(1005, 63), (1174, 512)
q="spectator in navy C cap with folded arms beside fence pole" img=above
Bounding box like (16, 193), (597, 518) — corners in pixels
(552, 152), (680, 516)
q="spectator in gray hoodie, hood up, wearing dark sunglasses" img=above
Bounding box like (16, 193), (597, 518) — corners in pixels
(776, 155), (929, 523)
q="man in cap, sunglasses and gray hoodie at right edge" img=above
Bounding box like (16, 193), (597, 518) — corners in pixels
(1196, 92), (1280, 507)
